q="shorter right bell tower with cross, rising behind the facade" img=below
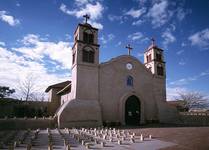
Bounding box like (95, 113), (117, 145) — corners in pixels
(144, 38), (166, 78)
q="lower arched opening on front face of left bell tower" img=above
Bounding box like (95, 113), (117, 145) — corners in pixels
(83, 47), (94, 63)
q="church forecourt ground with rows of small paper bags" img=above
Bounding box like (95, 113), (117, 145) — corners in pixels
(0, 127), (209, 150)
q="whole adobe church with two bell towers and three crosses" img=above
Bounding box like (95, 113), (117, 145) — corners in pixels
(46, 16), (178, 127)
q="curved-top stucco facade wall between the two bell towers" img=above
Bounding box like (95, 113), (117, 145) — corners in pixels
(99, 55), (157, 124)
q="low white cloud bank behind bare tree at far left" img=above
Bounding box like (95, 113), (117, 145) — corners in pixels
(0, 47), (69, 99)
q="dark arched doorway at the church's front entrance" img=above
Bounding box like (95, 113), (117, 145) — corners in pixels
(125, 95), (141, 125)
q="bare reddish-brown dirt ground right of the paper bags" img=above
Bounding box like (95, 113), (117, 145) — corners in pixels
(129, 127), (209, 150)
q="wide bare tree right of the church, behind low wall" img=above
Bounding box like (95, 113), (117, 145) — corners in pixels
(176, 92), (208, 111)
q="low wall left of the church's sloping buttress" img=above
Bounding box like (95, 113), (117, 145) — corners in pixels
(0, 118), (55, 130)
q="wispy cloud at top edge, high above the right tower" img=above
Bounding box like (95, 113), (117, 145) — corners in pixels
(147, 0), (173, 28)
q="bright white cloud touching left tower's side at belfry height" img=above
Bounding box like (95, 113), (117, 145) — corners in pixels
(13, 34), (72, 69)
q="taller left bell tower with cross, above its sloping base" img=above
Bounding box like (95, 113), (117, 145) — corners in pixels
(71, 15), (99, 100)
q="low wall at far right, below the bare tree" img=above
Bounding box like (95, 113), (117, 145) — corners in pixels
(180, 112), (209, 126)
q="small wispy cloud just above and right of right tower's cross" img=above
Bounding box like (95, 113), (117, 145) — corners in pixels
(162, 28), (176, 48)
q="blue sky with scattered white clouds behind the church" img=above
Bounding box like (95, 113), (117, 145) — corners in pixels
(0, 0), (209, 99)
